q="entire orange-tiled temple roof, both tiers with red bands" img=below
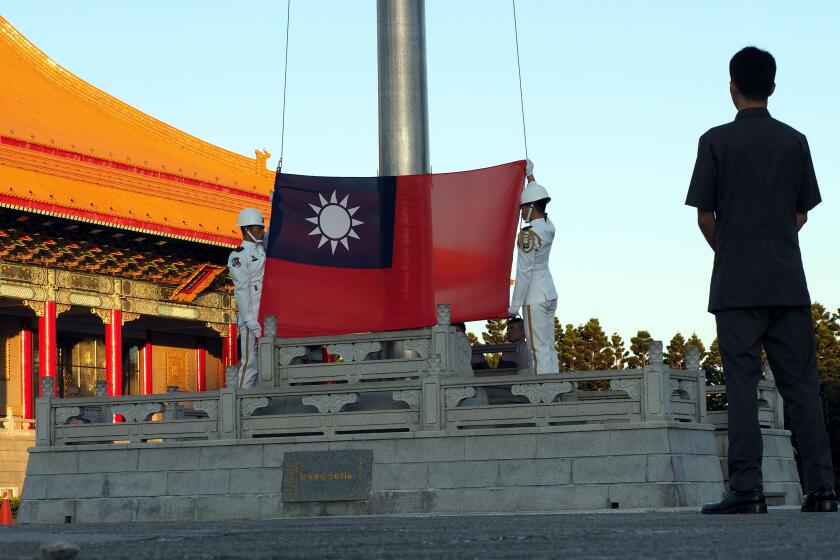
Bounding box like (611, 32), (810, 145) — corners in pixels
(0, 16), (274, 246)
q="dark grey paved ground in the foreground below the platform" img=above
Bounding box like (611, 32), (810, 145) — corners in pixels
(0, 508), (840, 560)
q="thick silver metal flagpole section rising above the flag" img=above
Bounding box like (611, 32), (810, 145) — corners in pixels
(376, 0), (430, 176)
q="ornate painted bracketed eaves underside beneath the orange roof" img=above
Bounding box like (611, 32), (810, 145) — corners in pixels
(0, 208), (231, 294)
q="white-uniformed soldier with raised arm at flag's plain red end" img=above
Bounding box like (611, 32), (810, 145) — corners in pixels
(508, 160), (560, 374)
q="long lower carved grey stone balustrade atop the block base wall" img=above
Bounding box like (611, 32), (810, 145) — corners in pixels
(31, 332), (740, 446)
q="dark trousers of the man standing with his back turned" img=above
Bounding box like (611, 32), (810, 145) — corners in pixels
(715, 306), (834, 491)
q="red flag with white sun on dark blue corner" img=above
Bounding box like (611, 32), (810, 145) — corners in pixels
(261, 162), (524, 338)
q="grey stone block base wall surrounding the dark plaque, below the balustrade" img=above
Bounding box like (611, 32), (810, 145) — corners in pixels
(21, 422), (723, 523)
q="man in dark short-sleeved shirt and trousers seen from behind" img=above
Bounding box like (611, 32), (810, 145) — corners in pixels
(686, 47), (837, 513)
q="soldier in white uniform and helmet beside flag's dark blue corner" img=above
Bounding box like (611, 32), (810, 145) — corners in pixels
(228, 208), (265, 388)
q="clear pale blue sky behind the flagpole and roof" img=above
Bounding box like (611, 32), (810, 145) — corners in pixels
(0, 0), (840, 345)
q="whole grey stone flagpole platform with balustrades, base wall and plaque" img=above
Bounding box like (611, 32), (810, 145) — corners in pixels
(13, 316), (801, 523)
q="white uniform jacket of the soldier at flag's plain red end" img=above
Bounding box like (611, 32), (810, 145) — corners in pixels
(510, 218), (557, 307)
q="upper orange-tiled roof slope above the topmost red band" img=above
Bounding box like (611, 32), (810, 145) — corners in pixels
(0, 16), (273, 194)
